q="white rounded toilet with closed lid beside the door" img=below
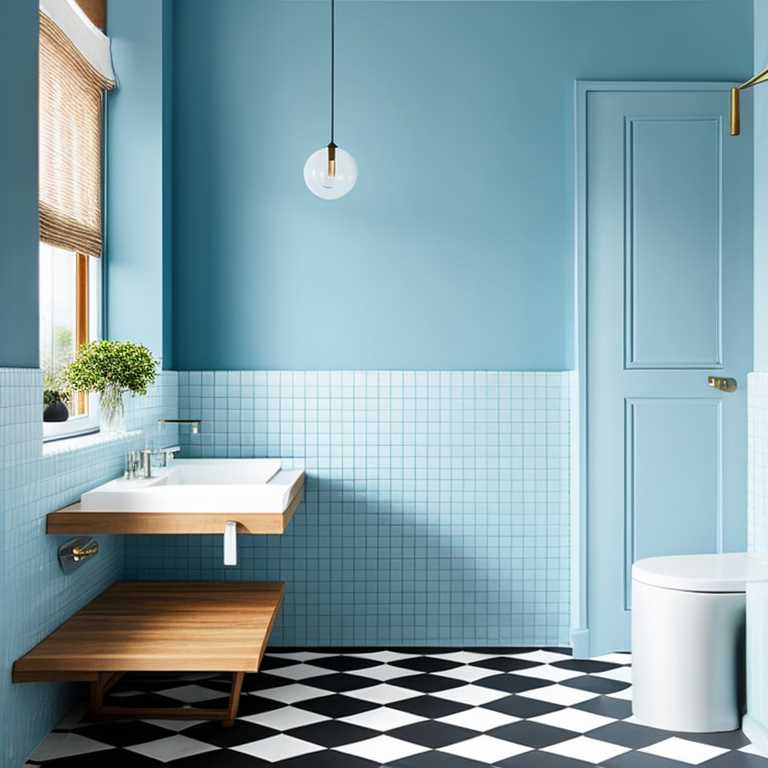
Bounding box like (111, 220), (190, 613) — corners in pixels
(632, 552), (768, 733)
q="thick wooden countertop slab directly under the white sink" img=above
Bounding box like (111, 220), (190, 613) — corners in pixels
(47, 479), (304, 534)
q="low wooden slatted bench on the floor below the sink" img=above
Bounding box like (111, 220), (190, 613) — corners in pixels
(13, 582), (283, 725)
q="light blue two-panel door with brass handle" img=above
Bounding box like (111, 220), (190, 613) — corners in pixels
(578, 83), (752, 654)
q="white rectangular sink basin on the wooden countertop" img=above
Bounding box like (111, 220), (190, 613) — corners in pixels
(80, 459), (304, 514)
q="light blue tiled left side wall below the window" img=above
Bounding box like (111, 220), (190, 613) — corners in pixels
(0, 369), (178, 768)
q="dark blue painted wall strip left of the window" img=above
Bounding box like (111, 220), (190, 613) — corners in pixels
(0, 0), (38, 367)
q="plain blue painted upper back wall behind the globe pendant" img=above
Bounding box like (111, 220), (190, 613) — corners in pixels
(174, 0), (752, 369)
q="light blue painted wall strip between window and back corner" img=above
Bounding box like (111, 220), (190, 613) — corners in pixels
(106, 0), (171, 368)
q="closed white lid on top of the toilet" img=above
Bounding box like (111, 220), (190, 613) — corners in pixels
(632, 552), (768, 592)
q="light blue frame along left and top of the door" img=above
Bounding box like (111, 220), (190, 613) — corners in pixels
(570, 80), (737, 658)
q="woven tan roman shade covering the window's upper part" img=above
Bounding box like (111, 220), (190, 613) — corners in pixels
(40, 13), (114, 256)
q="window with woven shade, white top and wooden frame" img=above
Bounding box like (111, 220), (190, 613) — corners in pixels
(39, 0), (114, 439)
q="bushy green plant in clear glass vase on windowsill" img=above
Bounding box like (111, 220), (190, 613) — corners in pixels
(64, 339), (157, 432)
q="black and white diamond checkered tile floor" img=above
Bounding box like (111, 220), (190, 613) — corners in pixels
(28, 648), (768, 768)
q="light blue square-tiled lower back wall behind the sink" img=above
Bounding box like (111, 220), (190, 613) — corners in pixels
(126, 371), (570, 645)
